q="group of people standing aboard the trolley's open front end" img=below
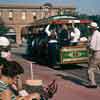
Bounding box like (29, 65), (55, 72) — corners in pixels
(45, 24), (81, 67)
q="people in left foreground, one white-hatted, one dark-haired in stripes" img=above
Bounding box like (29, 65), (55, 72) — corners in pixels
(0, 36), (57, 100)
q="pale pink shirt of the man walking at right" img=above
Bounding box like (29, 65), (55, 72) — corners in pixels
(90, 30), (100, 50)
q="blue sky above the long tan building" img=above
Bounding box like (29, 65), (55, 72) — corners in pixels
(0, 0), (100, 15)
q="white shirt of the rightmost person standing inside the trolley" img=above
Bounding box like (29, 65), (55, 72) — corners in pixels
(71, 27), (80, 42)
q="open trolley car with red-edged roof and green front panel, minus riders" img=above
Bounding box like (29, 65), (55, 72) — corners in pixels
(28, 15), (91, 64)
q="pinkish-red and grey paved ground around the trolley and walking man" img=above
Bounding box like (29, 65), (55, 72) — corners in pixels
(12, 45), (100, 100)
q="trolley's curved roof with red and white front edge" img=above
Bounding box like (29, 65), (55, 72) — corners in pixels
(31, 15), (91, 27)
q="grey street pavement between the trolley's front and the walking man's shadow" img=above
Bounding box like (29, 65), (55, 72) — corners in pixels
(59, 64), (100, 86)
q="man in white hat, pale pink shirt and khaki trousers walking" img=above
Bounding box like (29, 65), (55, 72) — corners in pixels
(87, 22), (100, 88)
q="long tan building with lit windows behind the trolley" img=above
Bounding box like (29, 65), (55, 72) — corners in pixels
(0, 3), (76, 45)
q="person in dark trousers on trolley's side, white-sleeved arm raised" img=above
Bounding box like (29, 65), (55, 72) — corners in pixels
(45, 25), (58, 67)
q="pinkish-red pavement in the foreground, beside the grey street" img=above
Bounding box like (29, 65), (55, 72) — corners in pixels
(14, 56), (100, 100)
